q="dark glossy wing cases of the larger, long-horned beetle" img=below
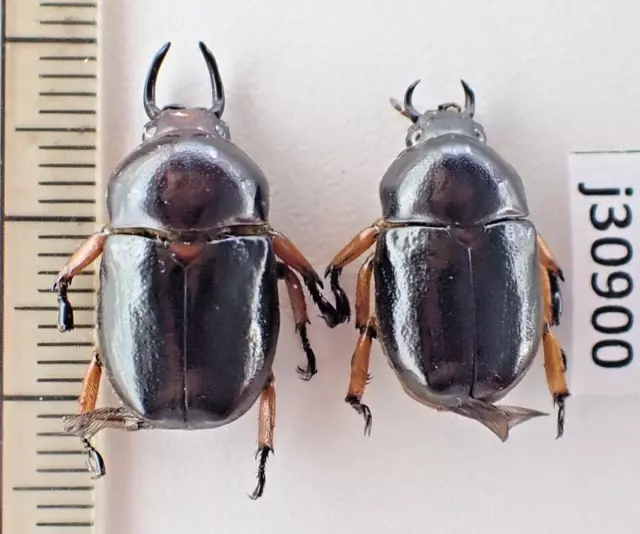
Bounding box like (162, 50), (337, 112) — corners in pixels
(98, 235), (280, 429)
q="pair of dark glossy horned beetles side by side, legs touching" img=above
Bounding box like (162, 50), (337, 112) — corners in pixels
(53, 43), (569, 498)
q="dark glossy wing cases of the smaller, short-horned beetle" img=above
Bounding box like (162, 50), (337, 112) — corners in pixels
(374, 220), (543, 406)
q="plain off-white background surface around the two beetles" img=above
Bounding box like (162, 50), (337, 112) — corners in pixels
(7, 0), (640, 534)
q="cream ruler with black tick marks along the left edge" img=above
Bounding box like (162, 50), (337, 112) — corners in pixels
(0, 0), (102, 534)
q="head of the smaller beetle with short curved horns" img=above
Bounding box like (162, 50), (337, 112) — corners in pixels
(391, 80), (486, 148)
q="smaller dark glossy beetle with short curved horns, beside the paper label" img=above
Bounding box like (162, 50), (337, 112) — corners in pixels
(324, 80), (569, 442)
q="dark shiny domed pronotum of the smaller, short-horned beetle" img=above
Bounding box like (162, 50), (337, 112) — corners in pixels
(380, 134), (529, 226)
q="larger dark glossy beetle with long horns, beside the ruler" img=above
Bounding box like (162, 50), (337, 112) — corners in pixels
(53, 42), (343, 499)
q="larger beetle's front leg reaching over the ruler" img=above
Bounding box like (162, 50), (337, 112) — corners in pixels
(52, 230), (108, 332)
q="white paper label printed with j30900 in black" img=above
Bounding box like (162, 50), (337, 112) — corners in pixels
(567, 151), (640, 395)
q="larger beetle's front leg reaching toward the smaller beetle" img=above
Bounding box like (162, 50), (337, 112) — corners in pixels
(270, 230), (349, 328)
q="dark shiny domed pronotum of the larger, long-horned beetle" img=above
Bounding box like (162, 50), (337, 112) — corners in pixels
(107, 134), (269, 231)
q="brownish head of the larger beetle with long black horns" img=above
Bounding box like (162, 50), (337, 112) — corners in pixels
(142, 42), (230, 141)
